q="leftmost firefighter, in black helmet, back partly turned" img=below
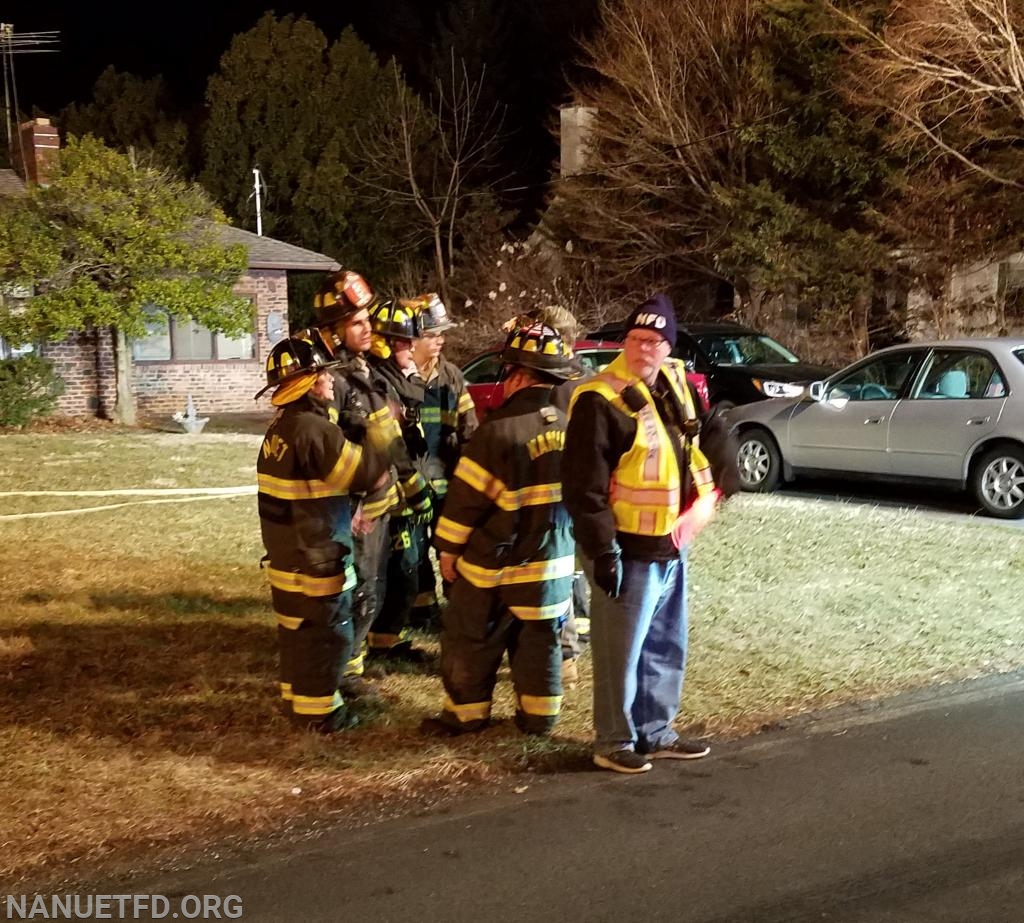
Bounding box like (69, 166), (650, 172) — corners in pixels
(256, 335), (387, 733)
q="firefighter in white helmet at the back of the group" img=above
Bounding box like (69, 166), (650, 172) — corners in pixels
(402, 292), (477, 628)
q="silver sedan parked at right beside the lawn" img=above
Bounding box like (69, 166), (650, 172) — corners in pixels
(728, 337), (1024, 519)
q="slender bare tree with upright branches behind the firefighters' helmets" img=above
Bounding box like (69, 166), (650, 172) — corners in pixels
(355, 55), (503, 302)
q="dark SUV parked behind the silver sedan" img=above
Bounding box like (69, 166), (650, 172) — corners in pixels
(587, 321), (835, 410)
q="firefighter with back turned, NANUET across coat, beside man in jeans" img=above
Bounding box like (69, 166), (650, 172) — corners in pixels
(421, 322), (579, 735)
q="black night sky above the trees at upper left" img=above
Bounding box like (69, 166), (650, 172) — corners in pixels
(0, 0), (452, 115)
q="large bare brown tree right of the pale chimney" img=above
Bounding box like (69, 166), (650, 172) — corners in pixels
(556, 0), (771, 285)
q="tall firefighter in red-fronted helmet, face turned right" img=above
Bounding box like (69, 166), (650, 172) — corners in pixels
(313, 270), (430, 698)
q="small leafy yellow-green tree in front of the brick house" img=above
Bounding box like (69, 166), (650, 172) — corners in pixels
(0, 137), (246, 424)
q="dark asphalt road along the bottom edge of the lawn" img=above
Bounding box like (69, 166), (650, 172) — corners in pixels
(97, 674), (1024, 923)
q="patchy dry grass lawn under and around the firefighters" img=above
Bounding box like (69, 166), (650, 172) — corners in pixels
(0, 432), (1024, 878)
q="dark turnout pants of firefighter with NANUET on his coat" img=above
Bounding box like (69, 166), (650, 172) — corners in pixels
(441, 579), (562, 735)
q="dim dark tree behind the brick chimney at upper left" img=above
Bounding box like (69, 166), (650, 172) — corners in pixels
(60, 66), (188, 173)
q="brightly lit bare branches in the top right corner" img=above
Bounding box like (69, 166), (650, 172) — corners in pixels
(828, 0), (1024, 186)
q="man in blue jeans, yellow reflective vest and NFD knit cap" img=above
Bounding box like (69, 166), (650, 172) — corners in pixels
(562, 295), (736, 772)
